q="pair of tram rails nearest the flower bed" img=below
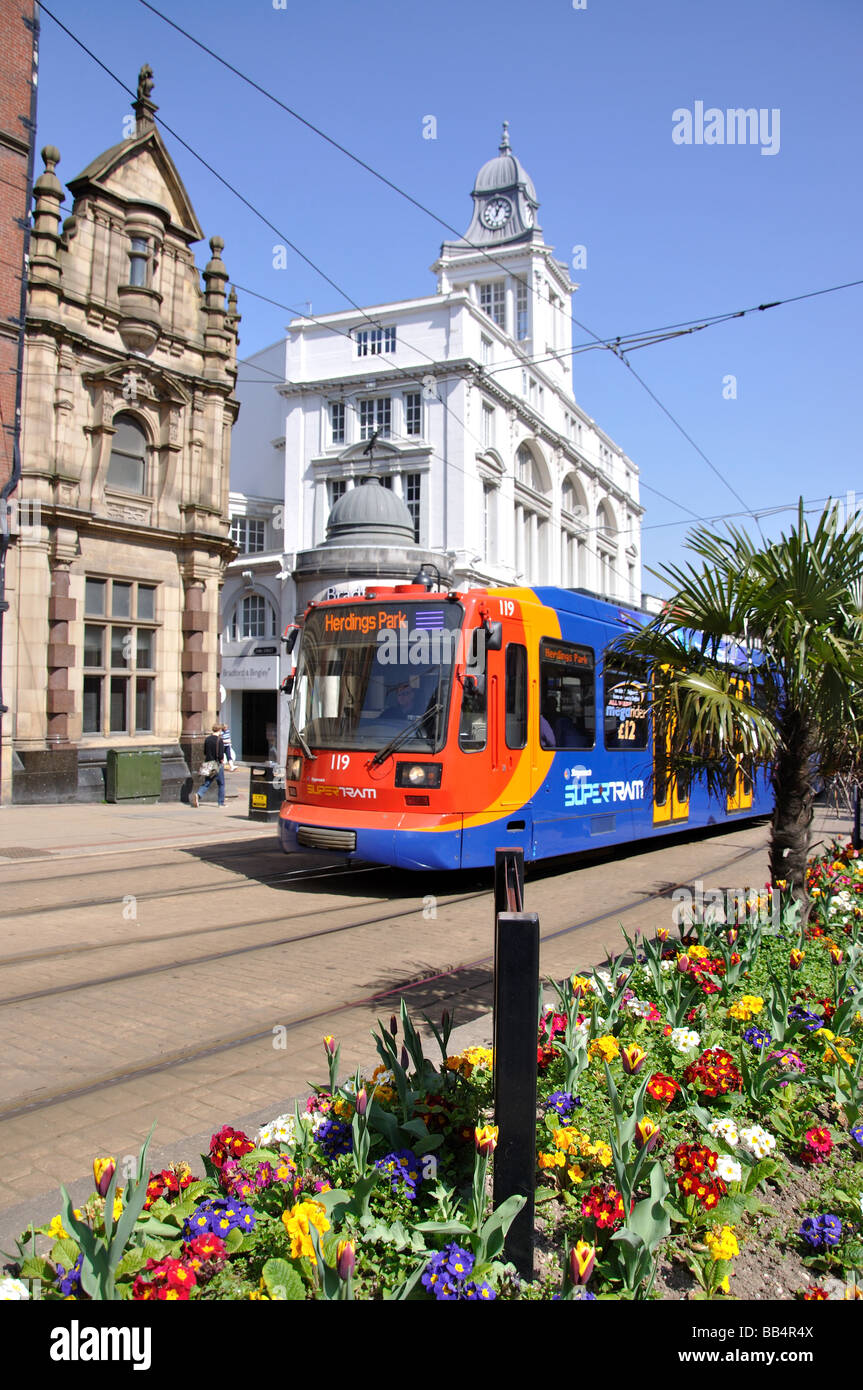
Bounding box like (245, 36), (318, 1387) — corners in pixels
(0, 828), (762, 1123)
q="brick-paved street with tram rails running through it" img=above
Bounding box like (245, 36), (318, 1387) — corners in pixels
(0, 808), (848, 1248)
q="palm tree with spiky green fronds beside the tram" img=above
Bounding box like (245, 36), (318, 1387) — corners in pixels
(610, 499), (863, 910)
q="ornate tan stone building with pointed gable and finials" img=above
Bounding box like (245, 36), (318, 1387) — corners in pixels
(6, 67), (239, 801)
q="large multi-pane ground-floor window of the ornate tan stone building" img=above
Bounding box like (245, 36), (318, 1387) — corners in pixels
(82, 578), (158, 738)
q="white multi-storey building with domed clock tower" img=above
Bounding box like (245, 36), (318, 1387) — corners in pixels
(222, 124), (642, 756)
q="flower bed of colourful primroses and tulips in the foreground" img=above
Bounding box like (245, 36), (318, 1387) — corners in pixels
(0, 847), (863, 1302)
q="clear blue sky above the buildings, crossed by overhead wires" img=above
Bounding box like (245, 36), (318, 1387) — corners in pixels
(39, 0), (863, 589)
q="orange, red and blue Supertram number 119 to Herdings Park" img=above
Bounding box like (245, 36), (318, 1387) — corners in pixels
(279, 584), (771, 869)
